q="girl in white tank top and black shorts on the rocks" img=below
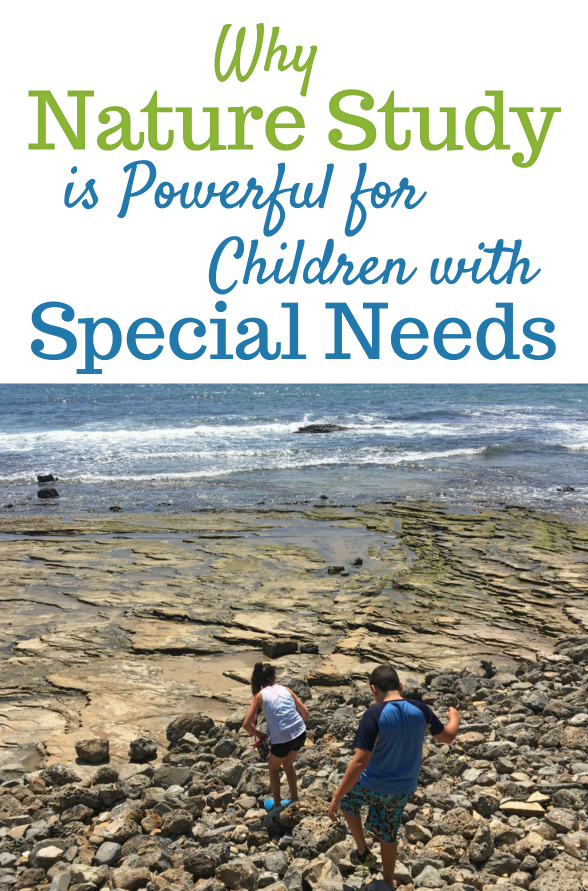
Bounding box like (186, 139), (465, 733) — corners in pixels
(243, 662), (308, 811)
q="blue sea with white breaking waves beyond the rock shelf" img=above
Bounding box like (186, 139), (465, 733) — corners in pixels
(0, 384), (588, 519)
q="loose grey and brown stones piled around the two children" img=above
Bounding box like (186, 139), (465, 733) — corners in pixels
(0, 635), (588, 891)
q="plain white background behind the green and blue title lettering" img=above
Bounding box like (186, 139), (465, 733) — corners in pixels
(0, 0), (588, 383)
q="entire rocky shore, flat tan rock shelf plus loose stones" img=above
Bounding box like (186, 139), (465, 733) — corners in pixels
(0, 502), (588, 891)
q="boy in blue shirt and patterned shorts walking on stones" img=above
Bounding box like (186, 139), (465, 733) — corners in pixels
(329, 665), (460, 888)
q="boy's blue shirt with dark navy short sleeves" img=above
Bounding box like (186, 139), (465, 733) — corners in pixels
(353, 699), (444, 795)
